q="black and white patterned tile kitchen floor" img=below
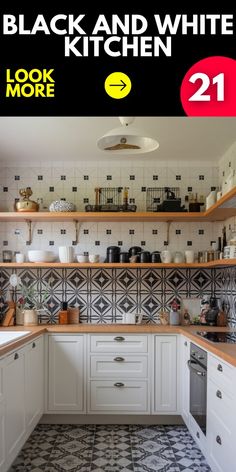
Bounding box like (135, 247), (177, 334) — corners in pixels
(9, 425), (210, 472)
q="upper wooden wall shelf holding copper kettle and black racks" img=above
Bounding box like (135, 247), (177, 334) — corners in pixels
(0, 187), (236, 223)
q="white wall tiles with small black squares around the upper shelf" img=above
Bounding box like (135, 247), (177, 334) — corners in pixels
(0, 160), (225, 256)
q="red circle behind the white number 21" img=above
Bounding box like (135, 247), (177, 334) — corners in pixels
(180, 56), (236, 116)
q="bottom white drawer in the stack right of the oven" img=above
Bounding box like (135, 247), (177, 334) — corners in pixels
(207, 410), (235, 472)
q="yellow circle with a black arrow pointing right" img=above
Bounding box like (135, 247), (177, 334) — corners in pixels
(104, 72), (132, 98)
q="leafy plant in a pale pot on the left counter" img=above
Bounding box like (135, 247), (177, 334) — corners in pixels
(16, 282), (49, 326)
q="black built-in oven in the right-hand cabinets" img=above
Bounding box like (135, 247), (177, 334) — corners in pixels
(188, 343), (207, 434)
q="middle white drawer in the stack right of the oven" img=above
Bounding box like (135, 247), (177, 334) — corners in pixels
(207, 380), (236, 433)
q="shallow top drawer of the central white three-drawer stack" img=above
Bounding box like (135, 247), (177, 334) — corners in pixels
(90, 333), (148, 354)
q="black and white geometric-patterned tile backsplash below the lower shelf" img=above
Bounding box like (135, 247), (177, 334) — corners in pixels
(0, 268), (221, 323)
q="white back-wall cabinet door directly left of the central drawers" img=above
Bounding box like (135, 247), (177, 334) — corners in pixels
(48, 335), (84, 411)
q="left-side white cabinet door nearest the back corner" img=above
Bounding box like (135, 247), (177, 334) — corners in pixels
(25, 336), (44, 429)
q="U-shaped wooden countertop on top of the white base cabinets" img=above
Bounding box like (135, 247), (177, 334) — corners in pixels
(0, 323), (236, 367)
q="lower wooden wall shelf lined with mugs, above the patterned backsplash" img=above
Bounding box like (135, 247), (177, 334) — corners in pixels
(0, 259), (236, 269)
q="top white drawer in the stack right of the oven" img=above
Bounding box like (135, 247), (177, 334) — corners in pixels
(208, 354), (236, 396)
